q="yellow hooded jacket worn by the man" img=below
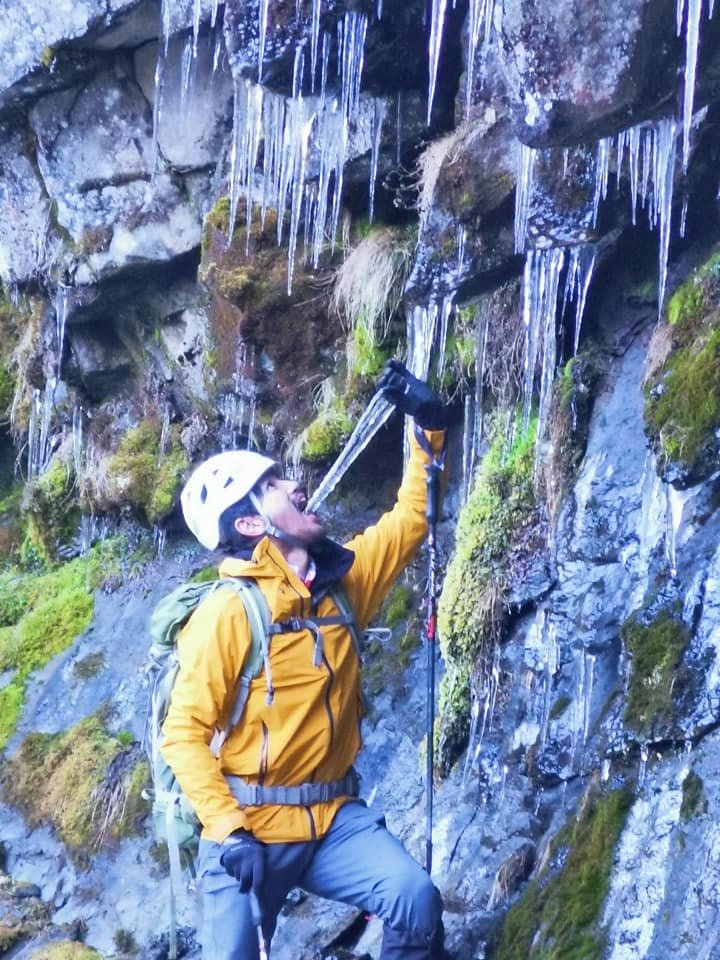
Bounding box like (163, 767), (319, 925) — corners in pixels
(162, 432), (443, 842)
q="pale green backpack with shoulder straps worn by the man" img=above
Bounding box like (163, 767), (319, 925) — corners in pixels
(143, 577), (360, 960)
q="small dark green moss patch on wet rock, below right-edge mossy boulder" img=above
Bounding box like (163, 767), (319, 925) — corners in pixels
(620, 610), (688, 739)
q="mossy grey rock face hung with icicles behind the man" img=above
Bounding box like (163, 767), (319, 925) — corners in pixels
(0, 0), (720, 960)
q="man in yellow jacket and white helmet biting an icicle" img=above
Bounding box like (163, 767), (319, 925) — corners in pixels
(162, 361), (445, 960)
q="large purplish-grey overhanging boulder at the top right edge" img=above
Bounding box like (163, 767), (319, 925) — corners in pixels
(501, 0), (682, 146)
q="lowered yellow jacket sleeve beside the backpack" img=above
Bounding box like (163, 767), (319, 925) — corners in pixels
(160, 591), (250, 843)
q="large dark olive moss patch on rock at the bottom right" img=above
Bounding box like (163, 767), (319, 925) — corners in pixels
(497, 789), (632, 960)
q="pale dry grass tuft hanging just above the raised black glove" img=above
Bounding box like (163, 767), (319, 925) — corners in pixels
(330, 227), (412, 342)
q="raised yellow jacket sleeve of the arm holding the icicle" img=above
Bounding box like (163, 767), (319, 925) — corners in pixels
(343, 430), (445, 629)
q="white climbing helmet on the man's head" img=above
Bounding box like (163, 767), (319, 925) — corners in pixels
(180, 450), (278, 550)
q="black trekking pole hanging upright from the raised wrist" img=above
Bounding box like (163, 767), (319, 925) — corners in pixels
(415, 428), (445, 875)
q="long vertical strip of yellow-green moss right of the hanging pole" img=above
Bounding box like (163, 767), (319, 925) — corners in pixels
(438, 412), (536, 772)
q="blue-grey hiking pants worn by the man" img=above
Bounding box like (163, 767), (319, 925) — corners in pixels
(198, 801), (443, 960)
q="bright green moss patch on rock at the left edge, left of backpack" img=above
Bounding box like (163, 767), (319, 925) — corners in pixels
(0, 541), (121, 748)
